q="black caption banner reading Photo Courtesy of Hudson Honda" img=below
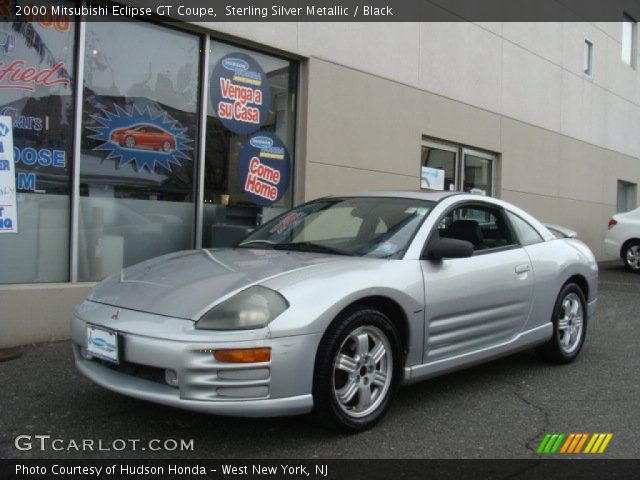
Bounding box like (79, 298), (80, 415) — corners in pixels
(0, 459), (640, 480)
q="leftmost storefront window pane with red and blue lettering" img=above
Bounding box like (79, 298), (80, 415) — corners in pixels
(0, 4), (75, 283)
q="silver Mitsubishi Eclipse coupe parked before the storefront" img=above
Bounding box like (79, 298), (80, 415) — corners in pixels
(72, 192), (598, 431)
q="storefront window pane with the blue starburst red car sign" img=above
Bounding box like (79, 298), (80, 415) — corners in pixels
(78, 22), (200, 281)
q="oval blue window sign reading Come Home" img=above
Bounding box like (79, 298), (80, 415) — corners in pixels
(238, 132), (291, 206)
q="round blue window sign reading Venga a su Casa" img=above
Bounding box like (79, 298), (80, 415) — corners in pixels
(211, 53), (271, 135)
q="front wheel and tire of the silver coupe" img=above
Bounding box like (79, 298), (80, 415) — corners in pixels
(313, 306), (402, 432)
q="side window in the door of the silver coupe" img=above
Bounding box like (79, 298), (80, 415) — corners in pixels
(438, 205), (517, 251)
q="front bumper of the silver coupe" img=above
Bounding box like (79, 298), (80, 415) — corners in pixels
(72, 306), (320, 417)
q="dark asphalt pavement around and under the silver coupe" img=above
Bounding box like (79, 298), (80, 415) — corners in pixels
(0, 264), (640, 458)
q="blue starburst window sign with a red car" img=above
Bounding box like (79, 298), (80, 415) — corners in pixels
(86, 105), (193, 172)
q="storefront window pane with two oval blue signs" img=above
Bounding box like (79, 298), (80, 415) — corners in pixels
(202, 41), (296, 247)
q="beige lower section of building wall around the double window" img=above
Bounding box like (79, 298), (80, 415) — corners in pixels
(305, 59), (640, 259)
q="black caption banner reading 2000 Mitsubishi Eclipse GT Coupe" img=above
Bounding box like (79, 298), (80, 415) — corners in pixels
(0, 0), (640, 22)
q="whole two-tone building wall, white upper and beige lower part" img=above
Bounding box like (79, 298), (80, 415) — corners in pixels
(210, 22), (640, 259)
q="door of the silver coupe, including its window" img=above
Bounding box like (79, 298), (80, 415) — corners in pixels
(420, 203), (533, 363)
